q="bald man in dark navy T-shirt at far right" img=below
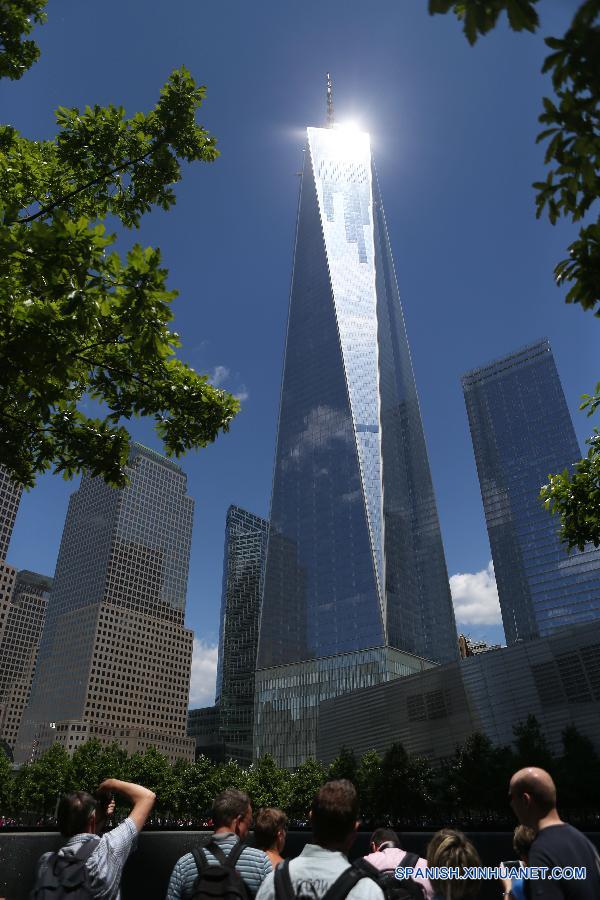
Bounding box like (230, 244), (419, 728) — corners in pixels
(508, 766), (600, 900)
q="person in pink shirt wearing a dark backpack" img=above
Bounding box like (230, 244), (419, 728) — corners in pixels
(364, 828), (434, 900)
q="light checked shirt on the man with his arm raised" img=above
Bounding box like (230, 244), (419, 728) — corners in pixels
(38, 818), (138, 900)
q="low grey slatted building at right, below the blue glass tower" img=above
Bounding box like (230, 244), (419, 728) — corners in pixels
(318, 621), (600, 765)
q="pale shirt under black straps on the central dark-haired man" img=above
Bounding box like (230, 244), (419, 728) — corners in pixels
(256, 844), (384, 900)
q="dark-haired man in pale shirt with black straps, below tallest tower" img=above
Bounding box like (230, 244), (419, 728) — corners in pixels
(256, 779), (384, 900)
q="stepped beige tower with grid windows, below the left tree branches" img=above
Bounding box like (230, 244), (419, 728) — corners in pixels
(15, 444), (194, 762)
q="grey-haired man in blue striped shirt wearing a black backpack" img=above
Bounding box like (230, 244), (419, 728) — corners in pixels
(167, 788), (272, 900)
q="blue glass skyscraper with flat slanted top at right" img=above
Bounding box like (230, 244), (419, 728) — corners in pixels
(462, 340), (600, 644)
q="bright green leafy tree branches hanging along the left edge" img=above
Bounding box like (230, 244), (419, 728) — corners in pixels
(0, 0), (239, 487)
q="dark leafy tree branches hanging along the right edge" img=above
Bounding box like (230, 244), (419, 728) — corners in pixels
(429, 0), (600, 550)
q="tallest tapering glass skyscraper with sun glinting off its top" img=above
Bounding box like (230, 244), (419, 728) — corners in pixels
(255, 119), (457, 766)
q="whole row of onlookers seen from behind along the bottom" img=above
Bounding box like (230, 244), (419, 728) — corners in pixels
(25, 768), (600, 900)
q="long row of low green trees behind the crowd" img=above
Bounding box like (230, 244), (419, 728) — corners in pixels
(0, 716), (600, 828)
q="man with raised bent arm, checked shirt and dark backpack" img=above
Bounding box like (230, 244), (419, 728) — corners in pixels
(31, 778), (156, 900)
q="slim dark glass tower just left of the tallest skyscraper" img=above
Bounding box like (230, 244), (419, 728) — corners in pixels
(216, 506), (269, 763)
